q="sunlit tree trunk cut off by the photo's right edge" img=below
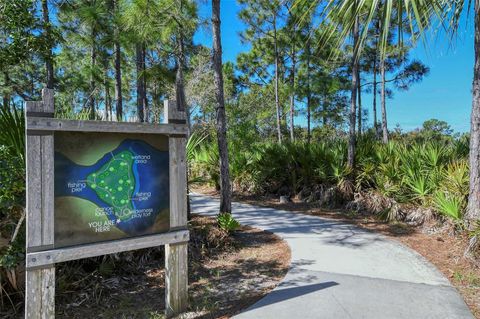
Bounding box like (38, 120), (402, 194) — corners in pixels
(465, 0), (480, 227)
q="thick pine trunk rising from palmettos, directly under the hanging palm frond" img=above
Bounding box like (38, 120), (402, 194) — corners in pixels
(347, 17), (360, 168)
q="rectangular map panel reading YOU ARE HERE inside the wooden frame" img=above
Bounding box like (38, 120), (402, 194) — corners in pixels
(54, 131), (170, 248)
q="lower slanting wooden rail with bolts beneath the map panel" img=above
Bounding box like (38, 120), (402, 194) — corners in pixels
(26, 230), (189, 269)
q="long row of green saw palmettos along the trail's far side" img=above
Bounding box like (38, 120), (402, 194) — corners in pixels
(193, 135), (468, 225)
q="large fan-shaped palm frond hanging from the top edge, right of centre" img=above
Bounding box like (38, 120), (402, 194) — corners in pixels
(294, 0), (458, 58)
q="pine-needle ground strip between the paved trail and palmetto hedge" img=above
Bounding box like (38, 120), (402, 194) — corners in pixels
(195, 187), (480, 318)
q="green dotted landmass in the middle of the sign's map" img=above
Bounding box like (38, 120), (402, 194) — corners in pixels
(87, 151), (135, 221)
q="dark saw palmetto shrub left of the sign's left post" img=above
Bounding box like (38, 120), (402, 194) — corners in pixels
(0, 108), (25, 303)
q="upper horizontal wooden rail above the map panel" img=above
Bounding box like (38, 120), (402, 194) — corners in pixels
(27, 117), (187, 135)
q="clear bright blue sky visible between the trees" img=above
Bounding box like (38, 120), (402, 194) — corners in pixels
(195, 0), (474, 132)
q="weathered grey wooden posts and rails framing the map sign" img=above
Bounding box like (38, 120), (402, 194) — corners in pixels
(25, 89), (189, 319)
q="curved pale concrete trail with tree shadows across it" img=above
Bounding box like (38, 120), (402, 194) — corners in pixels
(191, 195), (473, 319)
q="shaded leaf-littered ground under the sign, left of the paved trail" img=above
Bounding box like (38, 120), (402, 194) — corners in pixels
(0, 215), (290, 319)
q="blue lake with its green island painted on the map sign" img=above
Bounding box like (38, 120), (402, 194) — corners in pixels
(55, 139), (169, 236)
